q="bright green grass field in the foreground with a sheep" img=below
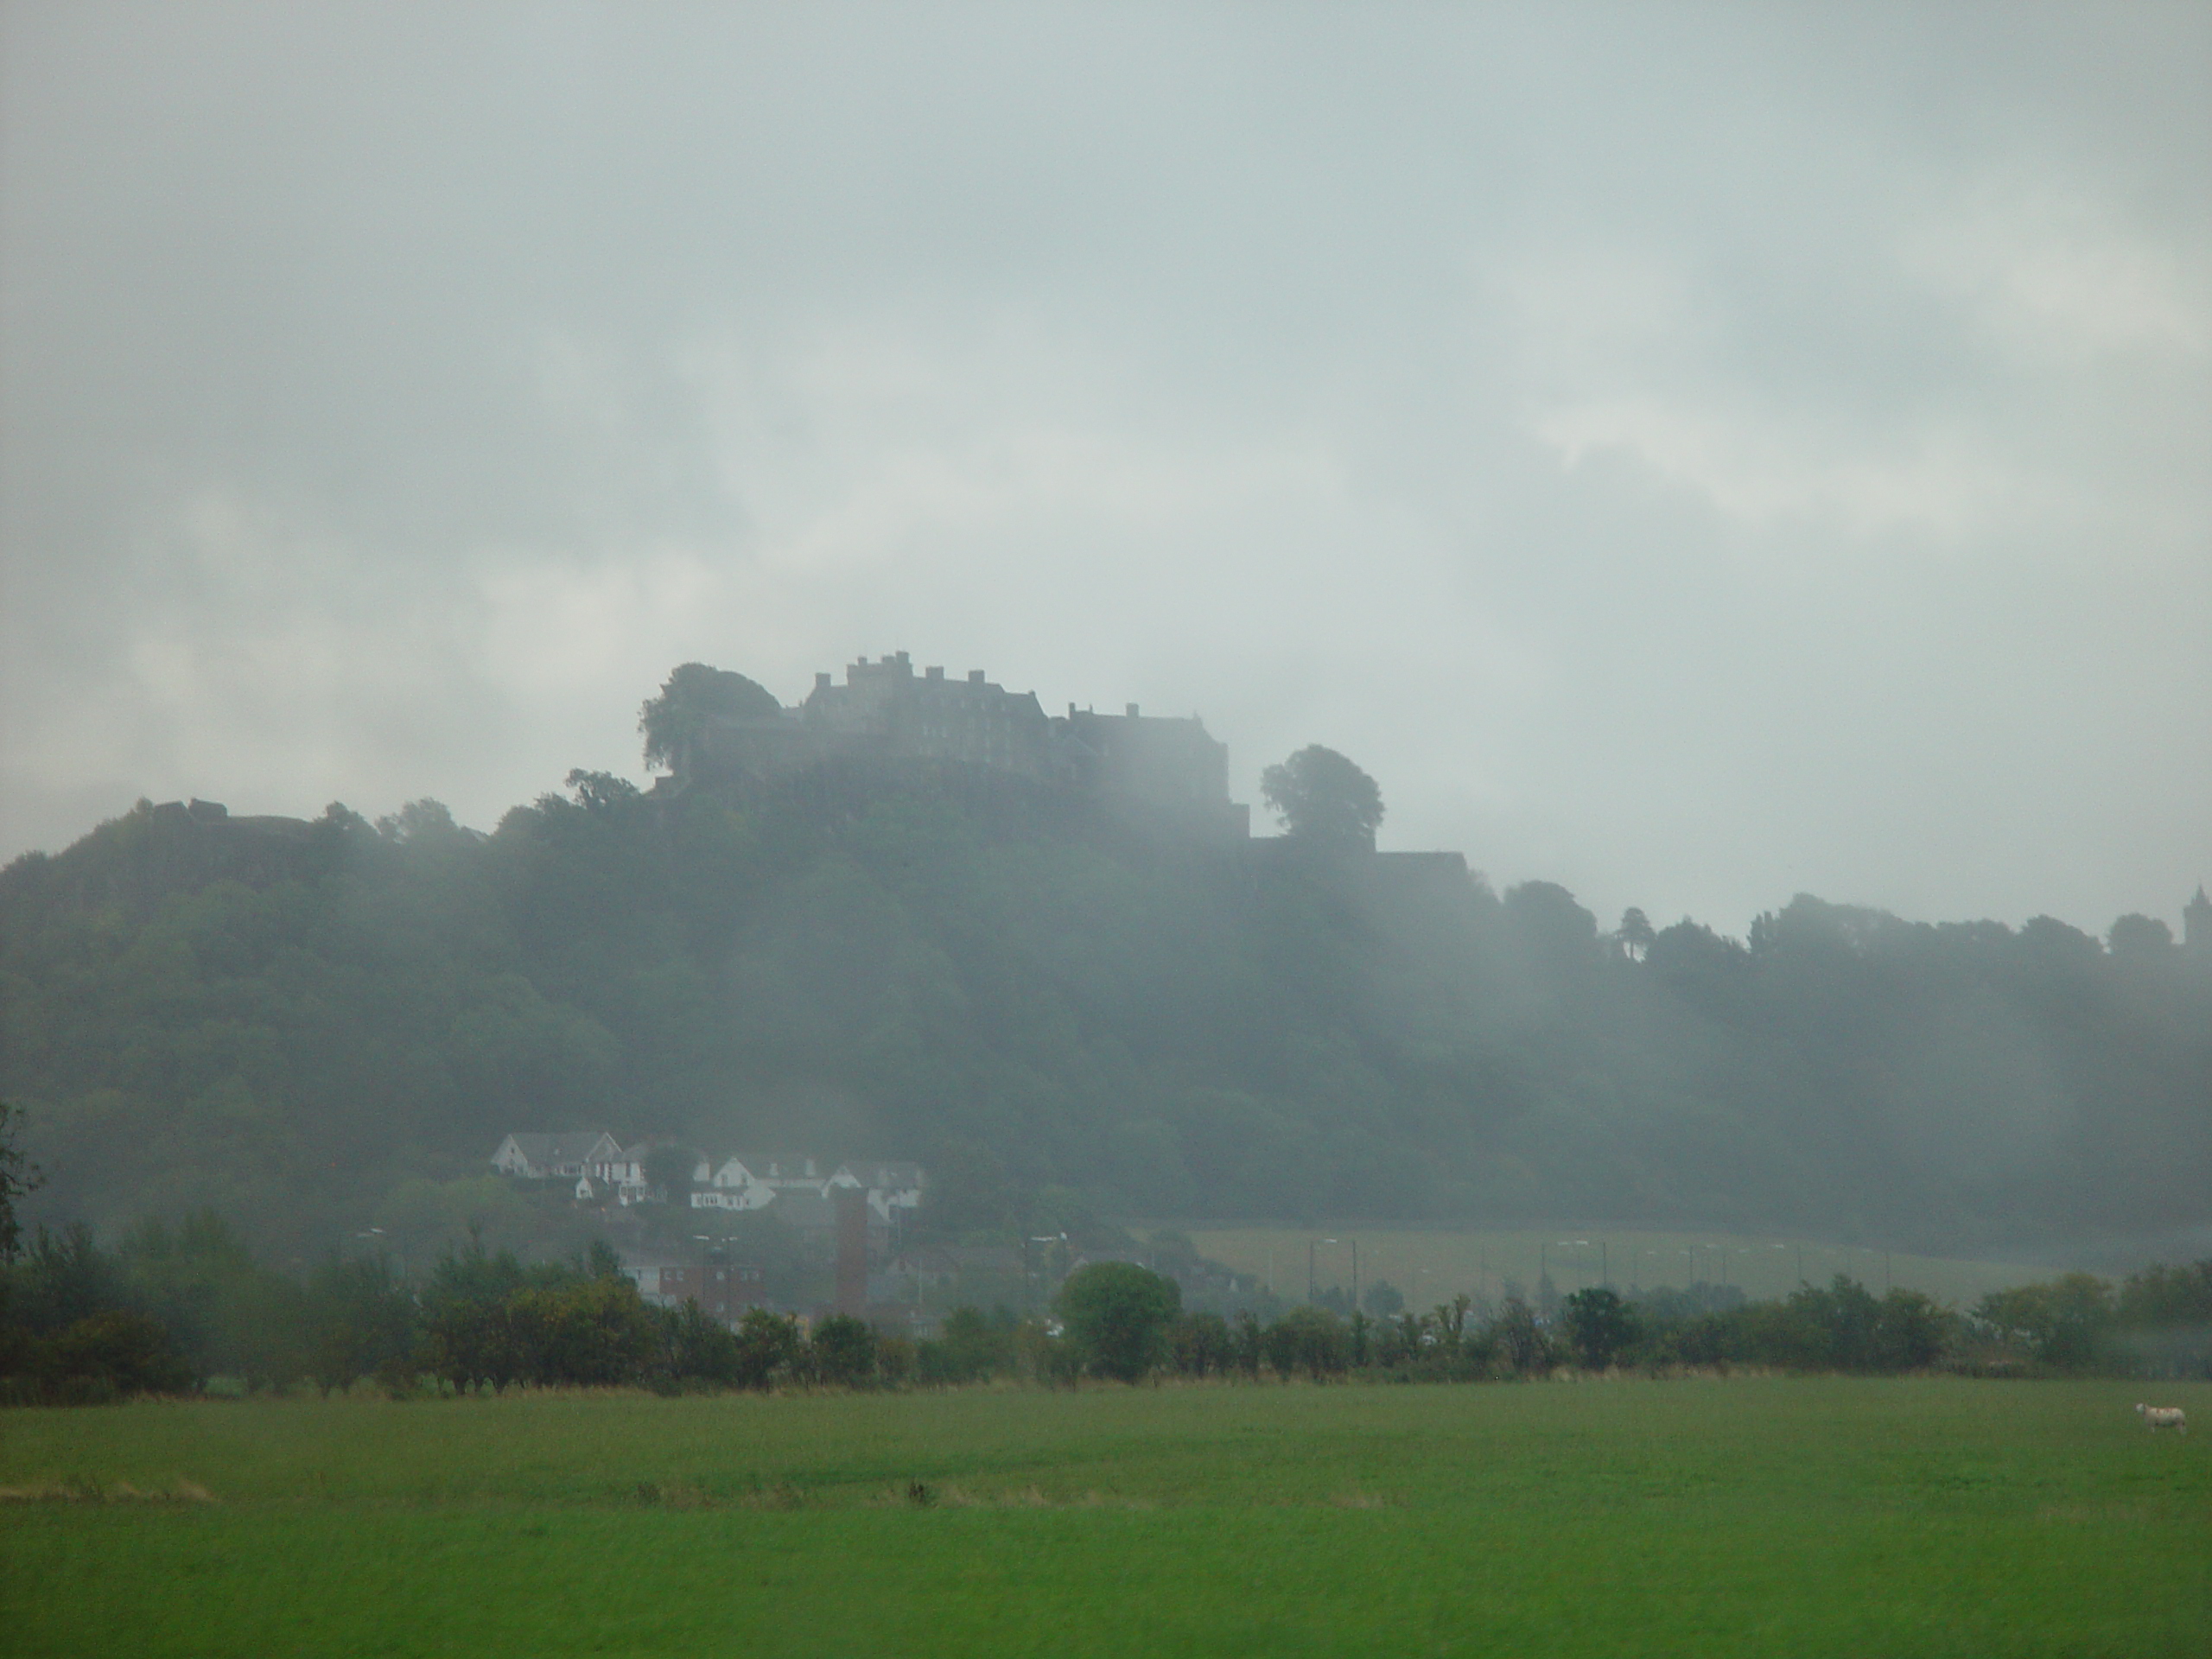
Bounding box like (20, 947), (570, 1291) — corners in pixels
(0, 1378), (2212, 1659)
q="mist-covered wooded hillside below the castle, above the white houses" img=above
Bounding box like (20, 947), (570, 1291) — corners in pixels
(0, 668), (2212, 1249)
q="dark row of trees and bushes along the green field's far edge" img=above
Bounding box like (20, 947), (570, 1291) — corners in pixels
(0, 1214), (2212, 1405)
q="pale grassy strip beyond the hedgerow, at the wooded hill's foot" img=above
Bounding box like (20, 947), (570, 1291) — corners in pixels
(1185, 1221), (2057, 1310)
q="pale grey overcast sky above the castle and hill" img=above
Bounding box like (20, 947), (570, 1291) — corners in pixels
(0, 0), (2212, 931)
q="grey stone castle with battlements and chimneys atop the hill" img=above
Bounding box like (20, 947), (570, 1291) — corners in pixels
(672, 651), (1252, 841)
